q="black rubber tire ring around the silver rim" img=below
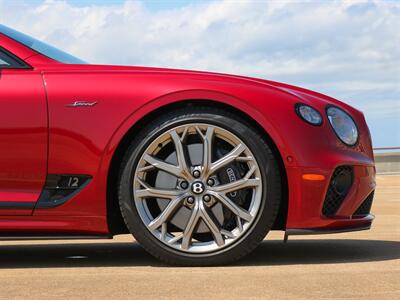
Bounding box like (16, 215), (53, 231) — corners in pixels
(118, 106), (281, 266)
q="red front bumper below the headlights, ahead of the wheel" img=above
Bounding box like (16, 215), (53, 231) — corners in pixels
(286, 161), (375, 234)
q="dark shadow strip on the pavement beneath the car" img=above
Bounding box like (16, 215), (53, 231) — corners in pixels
(0, 239), (400, 269)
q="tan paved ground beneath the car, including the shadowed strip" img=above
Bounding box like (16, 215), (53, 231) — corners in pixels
(0, 176), (400, 299)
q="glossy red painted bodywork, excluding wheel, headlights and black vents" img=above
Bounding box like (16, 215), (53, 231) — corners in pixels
(0, 34), (375, 235)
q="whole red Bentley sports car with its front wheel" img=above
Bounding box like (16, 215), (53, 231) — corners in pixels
(0, 26), (375, 265)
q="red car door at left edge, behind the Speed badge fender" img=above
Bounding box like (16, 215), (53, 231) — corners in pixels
(0, 47), (48, 216)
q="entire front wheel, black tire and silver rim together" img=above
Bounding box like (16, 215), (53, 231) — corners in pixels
(119, 107), (281, 265)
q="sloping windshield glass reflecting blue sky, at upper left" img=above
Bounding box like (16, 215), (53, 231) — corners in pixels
(0, 24), (86, 64)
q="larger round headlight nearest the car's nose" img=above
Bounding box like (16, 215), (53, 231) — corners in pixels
(326, 106), (358, 146)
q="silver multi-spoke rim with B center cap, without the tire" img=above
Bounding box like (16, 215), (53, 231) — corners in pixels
(132, 123), (263, 253)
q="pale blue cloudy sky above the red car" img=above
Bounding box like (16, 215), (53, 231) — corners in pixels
(0, 0), (400, 147)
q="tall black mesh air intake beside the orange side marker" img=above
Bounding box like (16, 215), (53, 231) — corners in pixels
(322, 166), (354, 217)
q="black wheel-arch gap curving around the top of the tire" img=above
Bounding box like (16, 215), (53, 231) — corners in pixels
(106, 98), (288, 234)
